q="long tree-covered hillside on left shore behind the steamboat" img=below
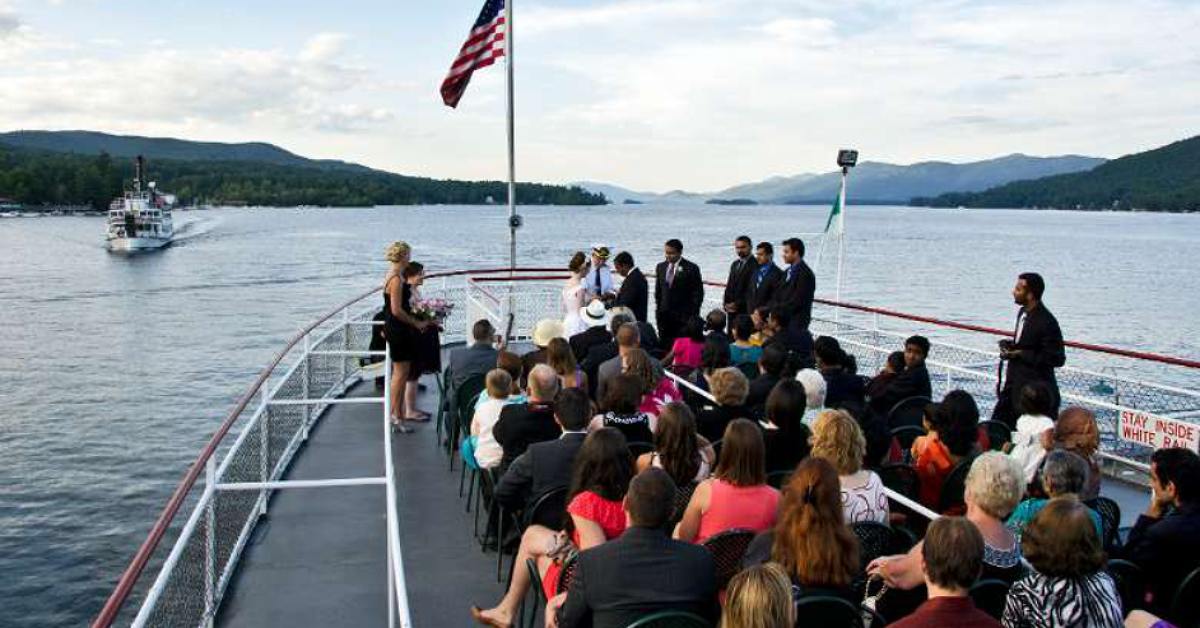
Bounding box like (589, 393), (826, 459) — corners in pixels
(0, 131), (607, 210)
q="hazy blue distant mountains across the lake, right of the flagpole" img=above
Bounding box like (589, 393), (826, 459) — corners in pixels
(575, 154), (1106, 204)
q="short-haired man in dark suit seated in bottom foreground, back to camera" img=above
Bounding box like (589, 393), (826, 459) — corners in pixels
(547, 468), (719, 628)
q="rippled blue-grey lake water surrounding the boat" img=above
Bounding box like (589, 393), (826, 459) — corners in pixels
(0, 205), (1200, 626)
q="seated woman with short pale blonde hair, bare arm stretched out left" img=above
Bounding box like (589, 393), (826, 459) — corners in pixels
(866, 451), (1025, 590)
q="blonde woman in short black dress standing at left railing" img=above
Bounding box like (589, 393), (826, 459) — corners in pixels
(383, 241), (433, 433)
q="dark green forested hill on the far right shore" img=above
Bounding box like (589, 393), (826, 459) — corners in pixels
(910, 136), (1200, 211)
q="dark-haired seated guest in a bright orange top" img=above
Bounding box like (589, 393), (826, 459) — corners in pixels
(912, 390), (984, 508)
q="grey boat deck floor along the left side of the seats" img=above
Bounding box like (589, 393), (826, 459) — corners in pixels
(217, 377), (503, 627)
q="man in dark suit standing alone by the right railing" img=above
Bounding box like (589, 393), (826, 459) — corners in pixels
(991, 273), (1067, 427)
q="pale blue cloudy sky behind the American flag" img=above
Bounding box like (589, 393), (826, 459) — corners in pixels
(0, 0), (1200, 191)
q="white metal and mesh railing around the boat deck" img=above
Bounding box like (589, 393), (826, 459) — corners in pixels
(92, 269), (1200, 627)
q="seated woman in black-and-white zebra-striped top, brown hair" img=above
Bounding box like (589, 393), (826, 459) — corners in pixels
(1002, 497), (1124, 628)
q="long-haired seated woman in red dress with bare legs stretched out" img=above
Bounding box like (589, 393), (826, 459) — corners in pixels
(470, 429), (634, 627)
